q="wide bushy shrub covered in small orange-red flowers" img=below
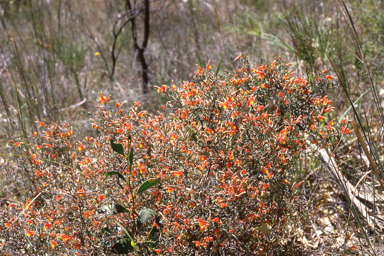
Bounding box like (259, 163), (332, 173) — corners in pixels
(0, 55), (337, 255)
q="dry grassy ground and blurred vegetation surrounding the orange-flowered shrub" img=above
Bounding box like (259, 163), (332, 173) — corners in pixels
(0, 0), (384, 255)
